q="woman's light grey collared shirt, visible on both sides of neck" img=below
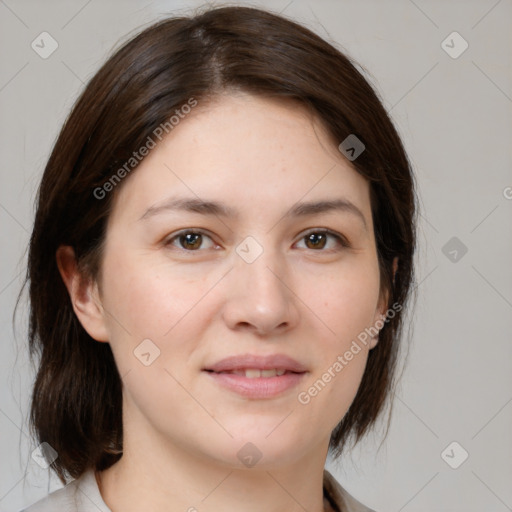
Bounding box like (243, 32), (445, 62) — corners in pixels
(21, 469), (374, 512)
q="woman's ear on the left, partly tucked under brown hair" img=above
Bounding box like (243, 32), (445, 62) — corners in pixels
(56, 245), (108, 342)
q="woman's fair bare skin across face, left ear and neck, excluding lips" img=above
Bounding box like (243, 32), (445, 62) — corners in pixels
(57, 93), (392, 512)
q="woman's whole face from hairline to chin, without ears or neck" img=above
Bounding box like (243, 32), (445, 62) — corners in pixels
(91, 94), (384, 467)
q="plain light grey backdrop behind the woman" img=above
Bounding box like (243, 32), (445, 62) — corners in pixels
(0, 0), (512, 512)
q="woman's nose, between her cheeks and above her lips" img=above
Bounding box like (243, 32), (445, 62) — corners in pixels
(223, 244), (300, 336)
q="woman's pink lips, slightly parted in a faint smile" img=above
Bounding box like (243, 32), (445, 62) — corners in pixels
(203, 354), (308, 399)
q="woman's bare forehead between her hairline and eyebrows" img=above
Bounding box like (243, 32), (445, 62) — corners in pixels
(109, 93), (370, 226)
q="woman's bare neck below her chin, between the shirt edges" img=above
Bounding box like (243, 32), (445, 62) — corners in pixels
(98, 418), (327, 512)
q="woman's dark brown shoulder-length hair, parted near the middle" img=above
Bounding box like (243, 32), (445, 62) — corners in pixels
(22, 7), (416, 483)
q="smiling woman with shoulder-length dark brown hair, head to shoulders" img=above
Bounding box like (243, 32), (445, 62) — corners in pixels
(26, 7), (415, 512)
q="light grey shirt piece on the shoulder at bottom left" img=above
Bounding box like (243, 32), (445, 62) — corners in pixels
(20, 469), (111, 512)
